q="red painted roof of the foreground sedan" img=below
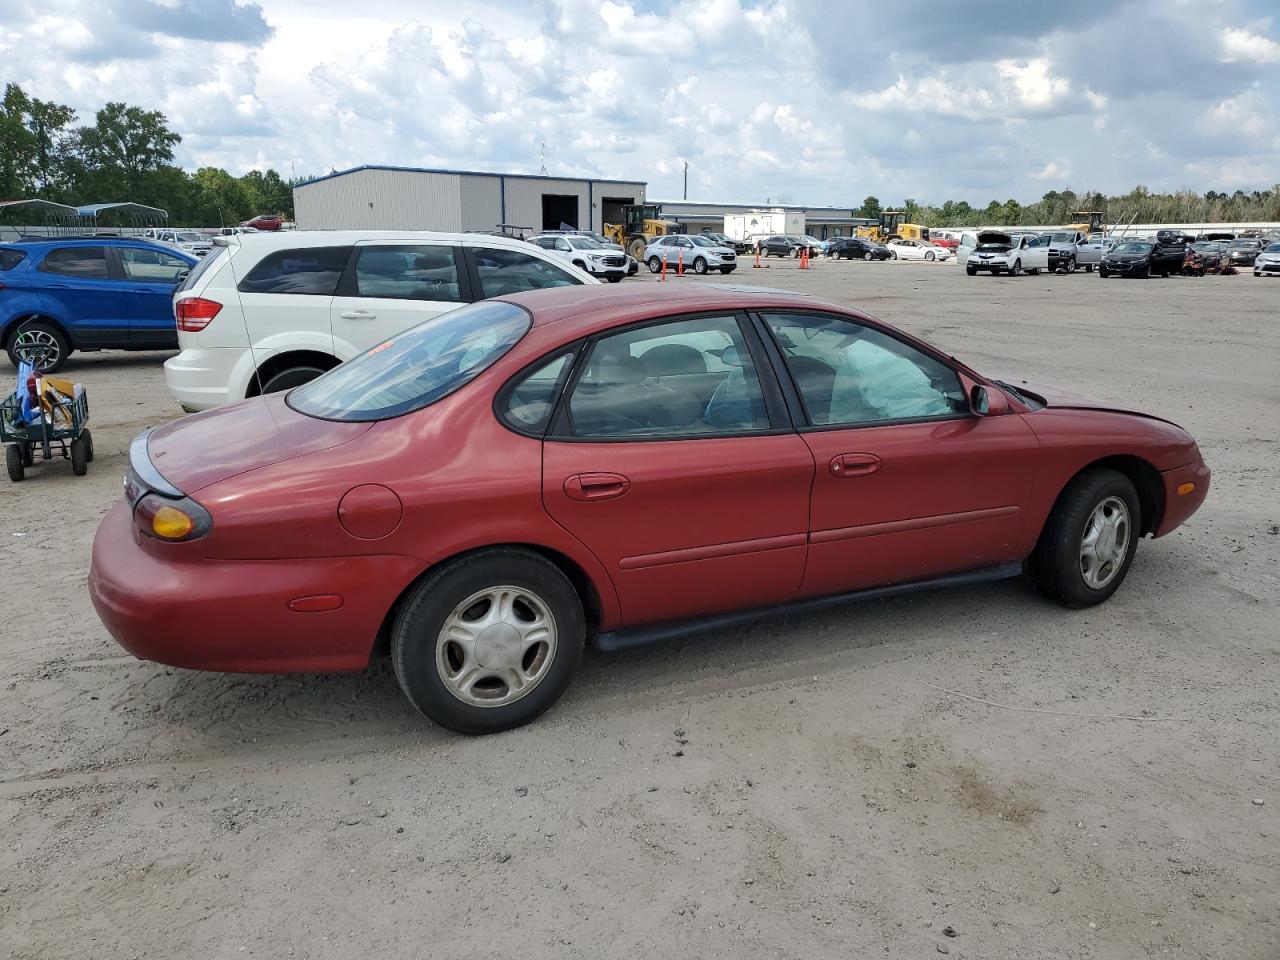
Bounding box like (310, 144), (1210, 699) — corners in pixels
(498, 283), (834, 342)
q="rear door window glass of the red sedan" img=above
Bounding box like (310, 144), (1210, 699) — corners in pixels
(568, 316), (769, 439)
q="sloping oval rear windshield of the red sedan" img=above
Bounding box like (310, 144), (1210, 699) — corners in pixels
(288, 300), (532, 420)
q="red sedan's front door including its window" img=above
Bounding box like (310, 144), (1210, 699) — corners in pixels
(760, 311), (1037, 595)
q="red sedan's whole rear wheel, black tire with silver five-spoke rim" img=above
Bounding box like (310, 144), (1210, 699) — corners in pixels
(392, 549), (586, 733)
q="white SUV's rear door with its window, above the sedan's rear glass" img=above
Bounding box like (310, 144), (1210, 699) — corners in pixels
(329, 241), (471, 356)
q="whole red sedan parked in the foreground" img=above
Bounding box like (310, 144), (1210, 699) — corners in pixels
(90, 285), (1210, 733)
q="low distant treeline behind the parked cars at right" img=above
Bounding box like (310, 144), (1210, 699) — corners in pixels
(858, 183), (1280, 234)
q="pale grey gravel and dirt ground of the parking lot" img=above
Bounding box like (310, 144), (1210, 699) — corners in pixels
(0, 260), (1280, 960)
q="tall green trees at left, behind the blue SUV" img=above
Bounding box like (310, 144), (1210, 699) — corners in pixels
(0, 83), (293, 227)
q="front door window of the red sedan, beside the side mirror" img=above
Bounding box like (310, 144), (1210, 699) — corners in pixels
(764, 314), (969, 426)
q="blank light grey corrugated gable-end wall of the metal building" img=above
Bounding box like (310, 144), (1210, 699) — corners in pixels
(293, 170), (463, 232)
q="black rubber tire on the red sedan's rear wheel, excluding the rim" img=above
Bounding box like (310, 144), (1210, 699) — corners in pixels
(392, 548), (586, 735)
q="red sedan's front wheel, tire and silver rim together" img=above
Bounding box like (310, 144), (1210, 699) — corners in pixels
(1029, 468), (1142, 608)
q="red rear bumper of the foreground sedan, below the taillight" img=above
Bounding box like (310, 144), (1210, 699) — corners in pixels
(88, 500), (422, 673)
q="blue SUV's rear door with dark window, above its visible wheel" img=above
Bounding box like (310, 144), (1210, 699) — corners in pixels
(36, 246), (129, 347)
